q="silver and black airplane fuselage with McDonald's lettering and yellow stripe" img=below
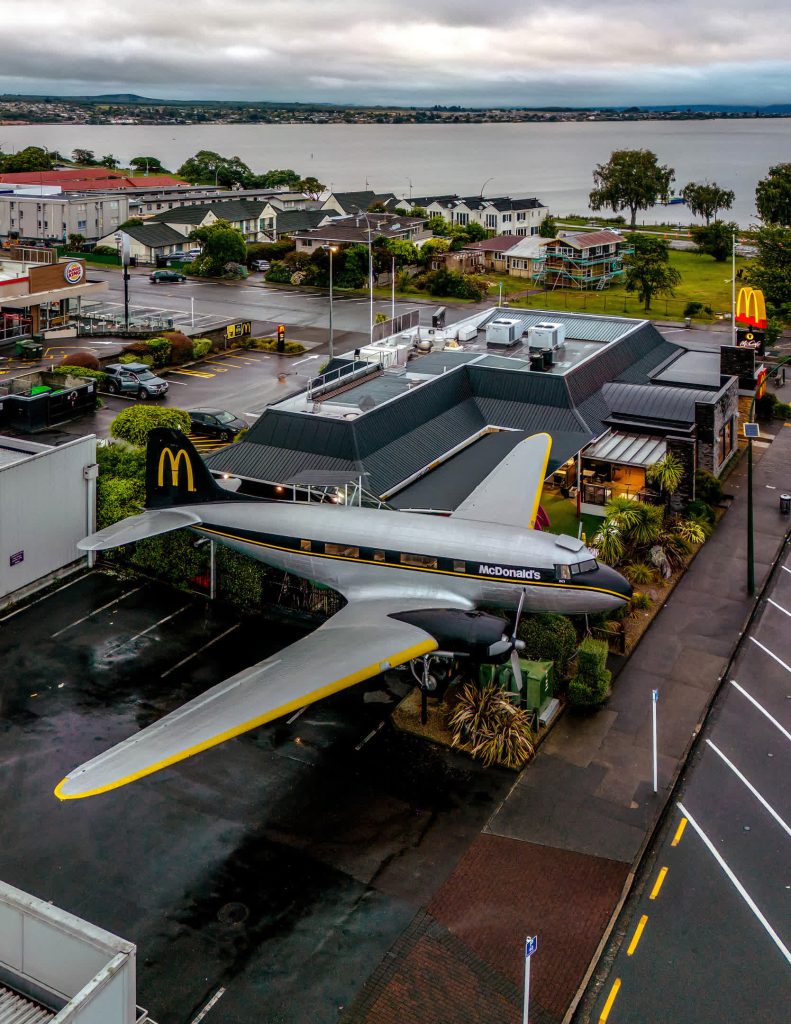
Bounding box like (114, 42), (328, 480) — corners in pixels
(190, 502), (631, 614)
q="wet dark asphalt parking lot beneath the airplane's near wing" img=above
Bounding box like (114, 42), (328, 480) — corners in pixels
(0, 572), (513, 1024)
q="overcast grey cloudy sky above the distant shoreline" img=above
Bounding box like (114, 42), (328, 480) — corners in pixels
(0, 0), (791, 106)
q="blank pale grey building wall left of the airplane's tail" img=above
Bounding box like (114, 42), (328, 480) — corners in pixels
(0, 436), (96, 600)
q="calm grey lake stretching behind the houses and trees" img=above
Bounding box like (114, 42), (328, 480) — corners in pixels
(0, 118), (791, 226)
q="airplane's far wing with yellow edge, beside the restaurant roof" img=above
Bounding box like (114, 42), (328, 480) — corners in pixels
(452, 433), (552, 529)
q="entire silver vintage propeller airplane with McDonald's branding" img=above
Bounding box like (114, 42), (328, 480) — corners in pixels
(55, 429), (631, 800)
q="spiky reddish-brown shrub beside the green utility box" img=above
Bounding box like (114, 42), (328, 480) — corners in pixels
(449, 683), (535, 768)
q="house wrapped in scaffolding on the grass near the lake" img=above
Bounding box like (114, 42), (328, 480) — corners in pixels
(535, 229), (632, 290)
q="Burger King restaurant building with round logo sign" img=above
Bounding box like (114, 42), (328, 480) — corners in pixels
(0, 249), (108, 344)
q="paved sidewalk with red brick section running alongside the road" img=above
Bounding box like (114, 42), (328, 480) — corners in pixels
(344, 424), (791, 1024)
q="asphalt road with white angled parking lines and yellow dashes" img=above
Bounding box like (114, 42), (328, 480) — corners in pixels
(587, 546), (791, 1024)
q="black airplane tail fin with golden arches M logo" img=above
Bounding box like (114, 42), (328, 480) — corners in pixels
(145, 427), (241, 509)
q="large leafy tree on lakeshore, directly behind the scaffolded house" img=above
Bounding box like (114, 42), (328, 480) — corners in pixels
(588, 150), (675, 230)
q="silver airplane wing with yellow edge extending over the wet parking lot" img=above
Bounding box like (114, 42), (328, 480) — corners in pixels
(55, 598), (438, 800)
